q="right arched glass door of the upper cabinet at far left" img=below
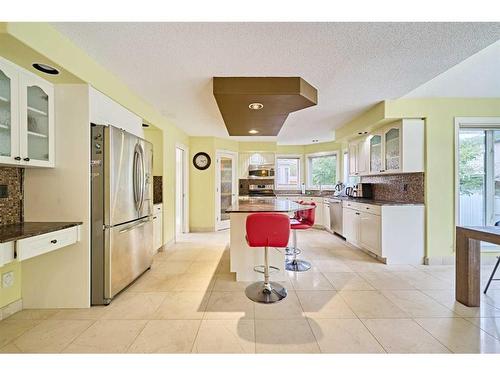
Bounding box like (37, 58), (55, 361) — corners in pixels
(20, 76), (54, 167)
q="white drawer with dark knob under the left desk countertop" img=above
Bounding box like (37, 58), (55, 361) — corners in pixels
(17, 226), (80, 260)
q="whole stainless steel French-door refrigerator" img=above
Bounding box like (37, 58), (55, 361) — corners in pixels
(90, 124), (153, 305)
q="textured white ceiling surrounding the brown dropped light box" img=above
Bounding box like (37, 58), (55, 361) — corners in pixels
(54, 23), (500, 144)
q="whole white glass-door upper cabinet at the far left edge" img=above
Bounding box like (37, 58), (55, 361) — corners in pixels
(0, 59), (55, 167)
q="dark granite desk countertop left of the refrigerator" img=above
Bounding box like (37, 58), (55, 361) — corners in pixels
(0, 222), (83, 243)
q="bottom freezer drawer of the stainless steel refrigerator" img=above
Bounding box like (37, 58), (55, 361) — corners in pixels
(104, 217), (153, 298)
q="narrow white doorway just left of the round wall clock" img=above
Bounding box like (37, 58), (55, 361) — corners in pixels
(175, 145), (188, 240)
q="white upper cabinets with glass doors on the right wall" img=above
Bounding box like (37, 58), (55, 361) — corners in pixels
(349, 119), (424, 176)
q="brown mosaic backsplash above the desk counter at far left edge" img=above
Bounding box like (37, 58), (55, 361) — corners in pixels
(0, 167), (24, 225)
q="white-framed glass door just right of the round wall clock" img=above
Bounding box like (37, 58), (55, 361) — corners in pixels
(215, 151), (238, 230)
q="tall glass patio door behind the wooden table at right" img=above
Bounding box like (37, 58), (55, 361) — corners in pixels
(458, 127), (500, 226)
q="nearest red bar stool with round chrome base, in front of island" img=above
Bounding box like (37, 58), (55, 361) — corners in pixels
(245, 213), (290, 303)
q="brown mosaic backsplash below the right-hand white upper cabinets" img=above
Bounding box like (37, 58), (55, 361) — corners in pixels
(361, 173), (424, 203)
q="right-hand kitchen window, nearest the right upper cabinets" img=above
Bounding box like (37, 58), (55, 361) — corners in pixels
(306, 152), (337, 189)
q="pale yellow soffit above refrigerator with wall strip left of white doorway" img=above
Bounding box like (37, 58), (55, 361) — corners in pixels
(0, 22), (189, 247)
